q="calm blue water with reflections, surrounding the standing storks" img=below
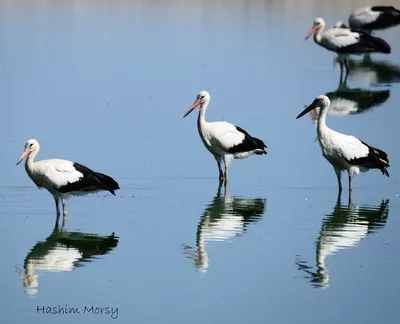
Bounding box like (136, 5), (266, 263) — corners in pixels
(0, 0), (400, 324)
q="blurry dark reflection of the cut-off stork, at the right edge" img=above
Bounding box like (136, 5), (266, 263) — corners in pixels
(334, 56), (400, 85)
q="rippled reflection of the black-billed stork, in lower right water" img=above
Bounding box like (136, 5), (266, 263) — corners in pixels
(296, 197), (389, 288)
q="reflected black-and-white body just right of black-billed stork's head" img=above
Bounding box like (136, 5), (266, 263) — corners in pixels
(325, 88), (390, 114)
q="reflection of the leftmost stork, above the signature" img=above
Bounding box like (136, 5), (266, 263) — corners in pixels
(16, 216), (118, 295)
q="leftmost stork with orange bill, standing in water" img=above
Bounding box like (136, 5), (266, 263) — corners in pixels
(17, 139), (119, 217)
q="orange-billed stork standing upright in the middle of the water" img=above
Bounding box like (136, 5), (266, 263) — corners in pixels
(183, 91), (267, 182)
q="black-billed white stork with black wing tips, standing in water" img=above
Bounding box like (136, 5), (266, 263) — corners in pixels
(296, 96), (389, 197)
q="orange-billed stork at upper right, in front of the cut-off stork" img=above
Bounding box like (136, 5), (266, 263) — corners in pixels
(305, 18), (391, 75)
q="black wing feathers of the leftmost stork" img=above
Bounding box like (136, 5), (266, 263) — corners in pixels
(56, 162), (119, 196)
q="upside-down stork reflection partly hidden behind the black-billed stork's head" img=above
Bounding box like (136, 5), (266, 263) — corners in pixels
(310, 77), (390, 126)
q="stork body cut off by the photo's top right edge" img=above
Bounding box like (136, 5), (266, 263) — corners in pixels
(349, 6), (400, 33)
